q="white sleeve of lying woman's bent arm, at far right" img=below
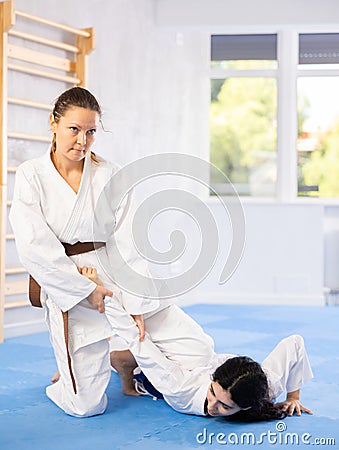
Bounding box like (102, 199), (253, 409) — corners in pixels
(261, 334), (313, 400)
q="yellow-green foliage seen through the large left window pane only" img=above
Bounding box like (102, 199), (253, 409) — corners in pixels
(210, 78), (277, 183)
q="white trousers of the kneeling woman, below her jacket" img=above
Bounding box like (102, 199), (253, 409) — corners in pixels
(45, 300), (111, 417)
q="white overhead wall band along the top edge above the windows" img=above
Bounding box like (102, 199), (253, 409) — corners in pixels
(156, 0), (339, 30)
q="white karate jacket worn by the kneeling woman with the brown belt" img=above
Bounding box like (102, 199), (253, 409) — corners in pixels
(9, 150), (159, 348)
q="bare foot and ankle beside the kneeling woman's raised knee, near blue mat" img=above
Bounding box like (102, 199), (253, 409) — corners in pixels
(110, 350), (140, 397)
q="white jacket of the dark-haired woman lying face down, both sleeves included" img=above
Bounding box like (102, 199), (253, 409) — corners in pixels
(105, 303), (313, 415)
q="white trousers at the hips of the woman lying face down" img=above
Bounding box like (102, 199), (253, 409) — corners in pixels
(106, 304), (214, 370)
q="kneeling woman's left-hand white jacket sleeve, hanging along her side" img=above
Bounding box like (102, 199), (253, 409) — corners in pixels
(9, 164), (96, 311)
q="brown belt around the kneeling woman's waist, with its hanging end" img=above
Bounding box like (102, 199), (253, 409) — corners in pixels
(29, 242), (105, 394)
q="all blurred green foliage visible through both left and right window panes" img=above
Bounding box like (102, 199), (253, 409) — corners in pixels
(210, 68), (339, 197)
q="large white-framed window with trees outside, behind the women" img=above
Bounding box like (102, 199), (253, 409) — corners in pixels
(210, 30), (339, 200)
